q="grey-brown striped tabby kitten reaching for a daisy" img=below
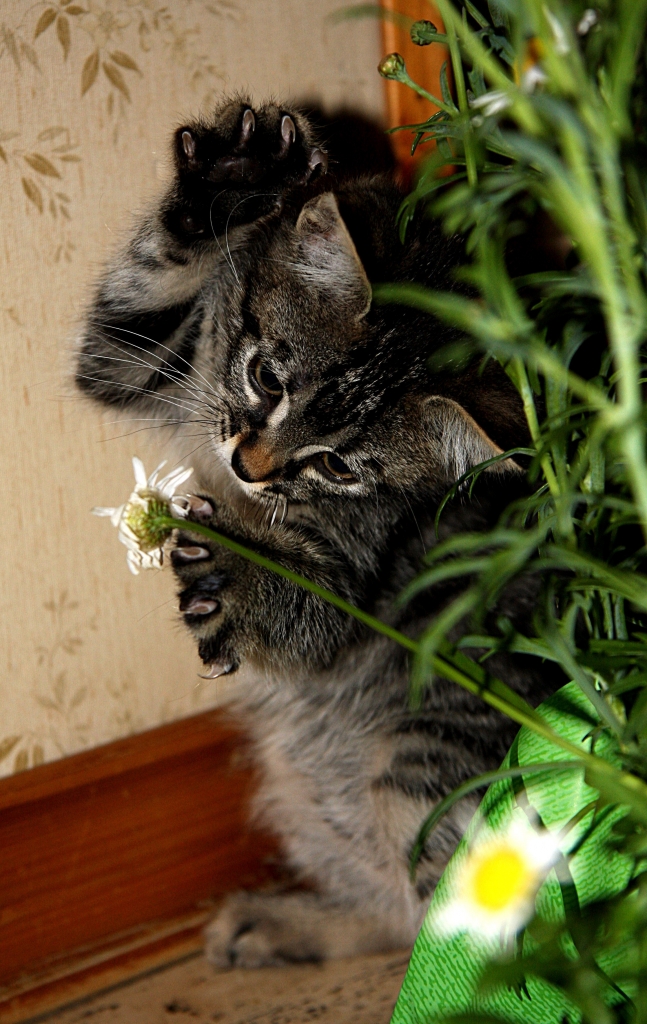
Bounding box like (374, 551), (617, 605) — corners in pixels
(78, 98), (551, 967)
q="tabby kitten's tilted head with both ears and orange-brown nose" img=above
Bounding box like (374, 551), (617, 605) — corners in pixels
(185, 193), (520, 516)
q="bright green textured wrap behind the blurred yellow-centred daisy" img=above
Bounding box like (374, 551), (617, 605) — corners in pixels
(391, 683), (632, 1024)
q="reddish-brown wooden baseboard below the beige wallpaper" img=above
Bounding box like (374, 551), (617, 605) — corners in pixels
(0, 712), (276, 1024)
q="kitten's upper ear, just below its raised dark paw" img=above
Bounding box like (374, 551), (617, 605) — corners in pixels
(296, 193), (371, 319)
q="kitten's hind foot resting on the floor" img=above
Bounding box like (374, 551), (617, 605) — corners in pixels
(205, 892), (416, 968)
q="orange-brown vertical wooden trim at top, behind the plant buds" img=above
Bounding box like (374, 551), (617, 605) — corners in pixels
(381, 0), (447, 173)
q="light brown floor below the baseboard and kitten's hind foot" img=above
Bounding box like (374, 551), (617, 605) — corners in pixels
(47, 951), (408, 1024)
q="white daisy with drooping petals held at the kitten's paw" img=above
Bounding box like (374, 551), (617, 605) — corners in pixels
(92, 457), (193, 575)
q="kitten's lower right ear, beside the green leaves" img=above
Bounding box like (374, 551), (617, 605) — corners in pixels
(423, 395), (520, 482)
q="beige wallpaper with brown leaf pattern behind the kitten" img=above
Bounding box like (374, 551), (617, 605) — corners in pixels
(0, 0), (382, 775)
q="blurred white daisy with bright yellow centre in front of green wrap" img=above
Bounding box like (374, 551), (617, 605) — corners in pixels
(430, 820), (560, 939)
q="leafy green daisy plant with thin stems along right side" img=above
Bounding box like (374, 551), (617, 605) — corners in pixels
(376, 0), (647, 1024)
